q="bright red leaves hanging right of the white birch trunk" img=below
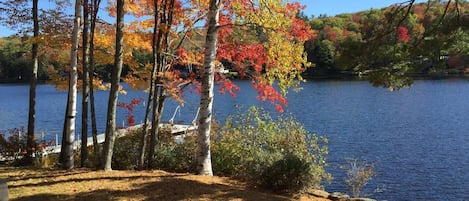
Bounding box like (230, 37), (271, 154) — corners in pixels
(200, 0), (312, 112)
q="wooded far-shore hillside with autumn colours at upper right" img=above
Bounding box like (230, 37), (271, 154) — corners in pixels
(299, 1), (469, 87)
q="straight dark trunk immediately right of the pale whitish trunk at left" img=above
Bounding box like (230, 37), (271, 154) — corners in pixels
(80, 0), (90, 167)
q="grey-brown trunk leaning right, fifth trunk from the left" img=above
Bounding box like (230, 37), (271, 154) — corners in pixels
(102, 0), (124, 171)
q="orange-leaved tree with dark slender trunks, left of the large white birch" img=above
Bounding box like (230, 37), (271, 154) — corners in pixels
(109, 0), (203, 168)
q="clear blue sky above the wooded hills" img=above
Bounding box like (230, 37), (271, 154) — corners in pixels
(0, 0), (426, 37)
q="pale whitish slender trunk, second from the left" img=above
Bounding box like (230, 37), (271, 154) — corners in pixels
(61, 0), (81, 170)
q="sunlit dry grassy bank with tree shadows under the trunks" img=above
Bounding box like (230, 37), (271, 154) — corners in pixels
(0, 166), (327, 201)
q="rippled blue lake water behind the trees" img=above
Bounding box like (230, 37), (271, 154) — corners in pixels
(0, 79), (469, 201)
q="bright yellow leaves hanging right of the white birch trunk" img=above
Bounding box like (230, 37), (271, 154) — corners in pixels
(230, 0), (311, 95)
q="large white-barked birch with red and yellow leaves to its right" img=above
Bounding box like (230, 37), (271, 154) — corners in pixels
(197, 0), (312, 175)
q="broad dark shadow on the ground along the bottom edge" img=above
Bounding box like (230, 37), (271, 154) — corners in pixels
(11, 175), (290, 201)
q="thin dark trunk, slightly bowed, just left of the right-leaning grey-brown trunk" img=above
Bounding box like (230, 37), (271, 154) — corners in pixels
(88, 0), (101, 167)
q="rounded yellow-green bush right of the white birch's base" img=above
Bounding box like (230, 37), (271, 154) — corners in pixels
(212, 107), (330, 192)
